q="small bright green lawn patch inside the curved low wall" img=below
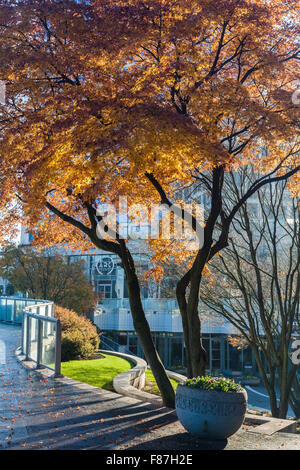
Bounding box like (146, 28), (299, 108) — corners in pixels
(61, 354), (132, 390)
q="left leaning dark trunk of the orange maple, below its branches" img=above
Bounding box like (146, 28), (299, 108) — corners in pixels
(122, 250), (175, 408)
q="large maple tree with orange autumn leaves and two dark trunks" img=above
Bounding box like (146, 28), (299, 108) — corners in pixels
(0, 0), (300, 406)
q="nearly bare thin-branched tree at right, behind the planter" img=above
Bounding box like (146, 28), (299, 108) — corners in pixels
(201, 169), (300, 418)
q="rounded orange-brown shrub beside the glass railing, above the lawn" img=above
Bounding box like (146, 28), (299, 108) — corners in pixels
(55, 305), (100, 361)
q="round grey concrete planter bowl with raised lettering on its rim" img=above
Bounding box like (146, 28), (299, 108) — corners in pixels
(176, 385), (248, 439)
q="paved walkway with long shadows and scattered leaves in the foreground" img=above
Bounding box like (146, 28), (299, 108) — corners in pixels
(0, 323), (300, 451)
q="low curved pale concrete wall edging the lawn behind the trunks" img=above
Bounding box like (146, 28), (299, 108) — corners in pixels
(99, 349), (186, 406)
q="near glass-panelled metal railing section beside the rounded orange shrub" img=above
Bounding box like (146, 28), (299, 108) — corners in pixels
(21, 302), (61, 377)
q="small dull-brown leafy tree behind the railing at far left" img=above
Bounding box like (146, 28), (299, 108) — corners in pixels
(0, 245), (96, 314)
